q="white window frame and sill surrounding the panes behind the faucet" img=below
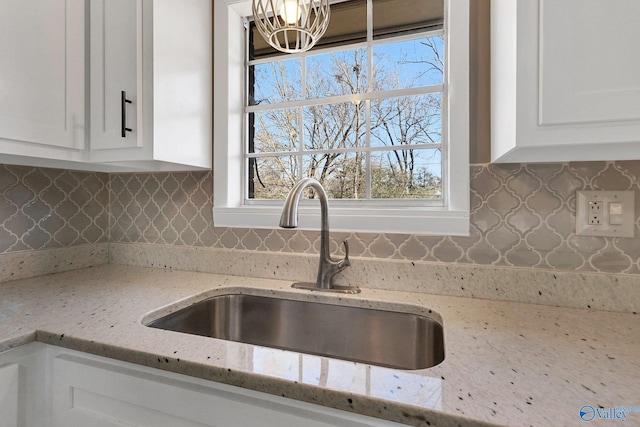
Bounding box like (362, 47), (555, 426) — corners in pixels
(213, 0), (469, 236)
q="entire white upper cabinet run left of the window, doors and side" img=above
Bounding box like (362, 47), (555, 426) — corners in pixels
(0, 0), (213, 171)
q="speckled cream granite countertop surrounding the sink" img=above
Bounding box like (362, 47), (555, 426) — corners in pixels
(0, 265), (640, 426)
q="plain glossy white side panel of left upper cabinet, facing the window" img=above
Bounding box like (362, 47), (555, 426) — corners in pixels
(145, 0), (213, 168)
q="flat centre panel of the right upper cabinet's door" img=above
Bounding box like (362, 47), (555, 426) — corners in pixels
(539, 0), (640, 126)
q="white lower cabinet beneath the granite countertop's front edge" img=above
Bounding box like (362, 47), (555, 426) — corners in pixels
(0, 343), (400, 427)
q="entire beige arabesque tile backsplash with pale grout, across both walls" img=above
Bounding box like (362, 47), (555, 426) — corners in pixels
(0, 161), (640, 274)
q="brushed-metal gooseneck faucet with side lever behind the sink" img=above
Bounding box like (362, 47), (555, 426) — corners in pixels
(280, 178), (360, 294)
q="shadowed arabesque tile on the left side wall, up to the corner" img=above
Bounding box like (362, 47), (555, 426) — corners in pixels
(0, 165), (109, 253)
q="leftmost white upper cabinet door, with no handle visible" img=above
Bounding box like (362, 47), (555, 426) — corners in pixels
(0, 0), (85, 154)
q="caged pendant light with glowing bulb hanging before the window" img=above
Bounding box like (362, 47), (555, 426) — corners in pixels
(252, 0), (330, 53)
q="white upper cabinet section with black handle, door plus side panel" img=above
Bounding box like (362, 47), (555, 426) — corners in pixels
(90, 0), (213, 170)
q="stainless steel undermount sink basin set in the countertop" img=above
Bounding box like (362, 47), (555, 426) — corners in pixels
(146, 294), (444, 369)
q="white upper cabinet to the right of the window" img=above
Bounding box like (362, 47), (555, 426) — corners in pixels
(491, 0), (640, 162)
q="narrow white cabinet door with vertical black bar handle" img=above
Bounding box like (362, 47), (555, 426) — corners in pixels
(90, 0), (142, 151)
